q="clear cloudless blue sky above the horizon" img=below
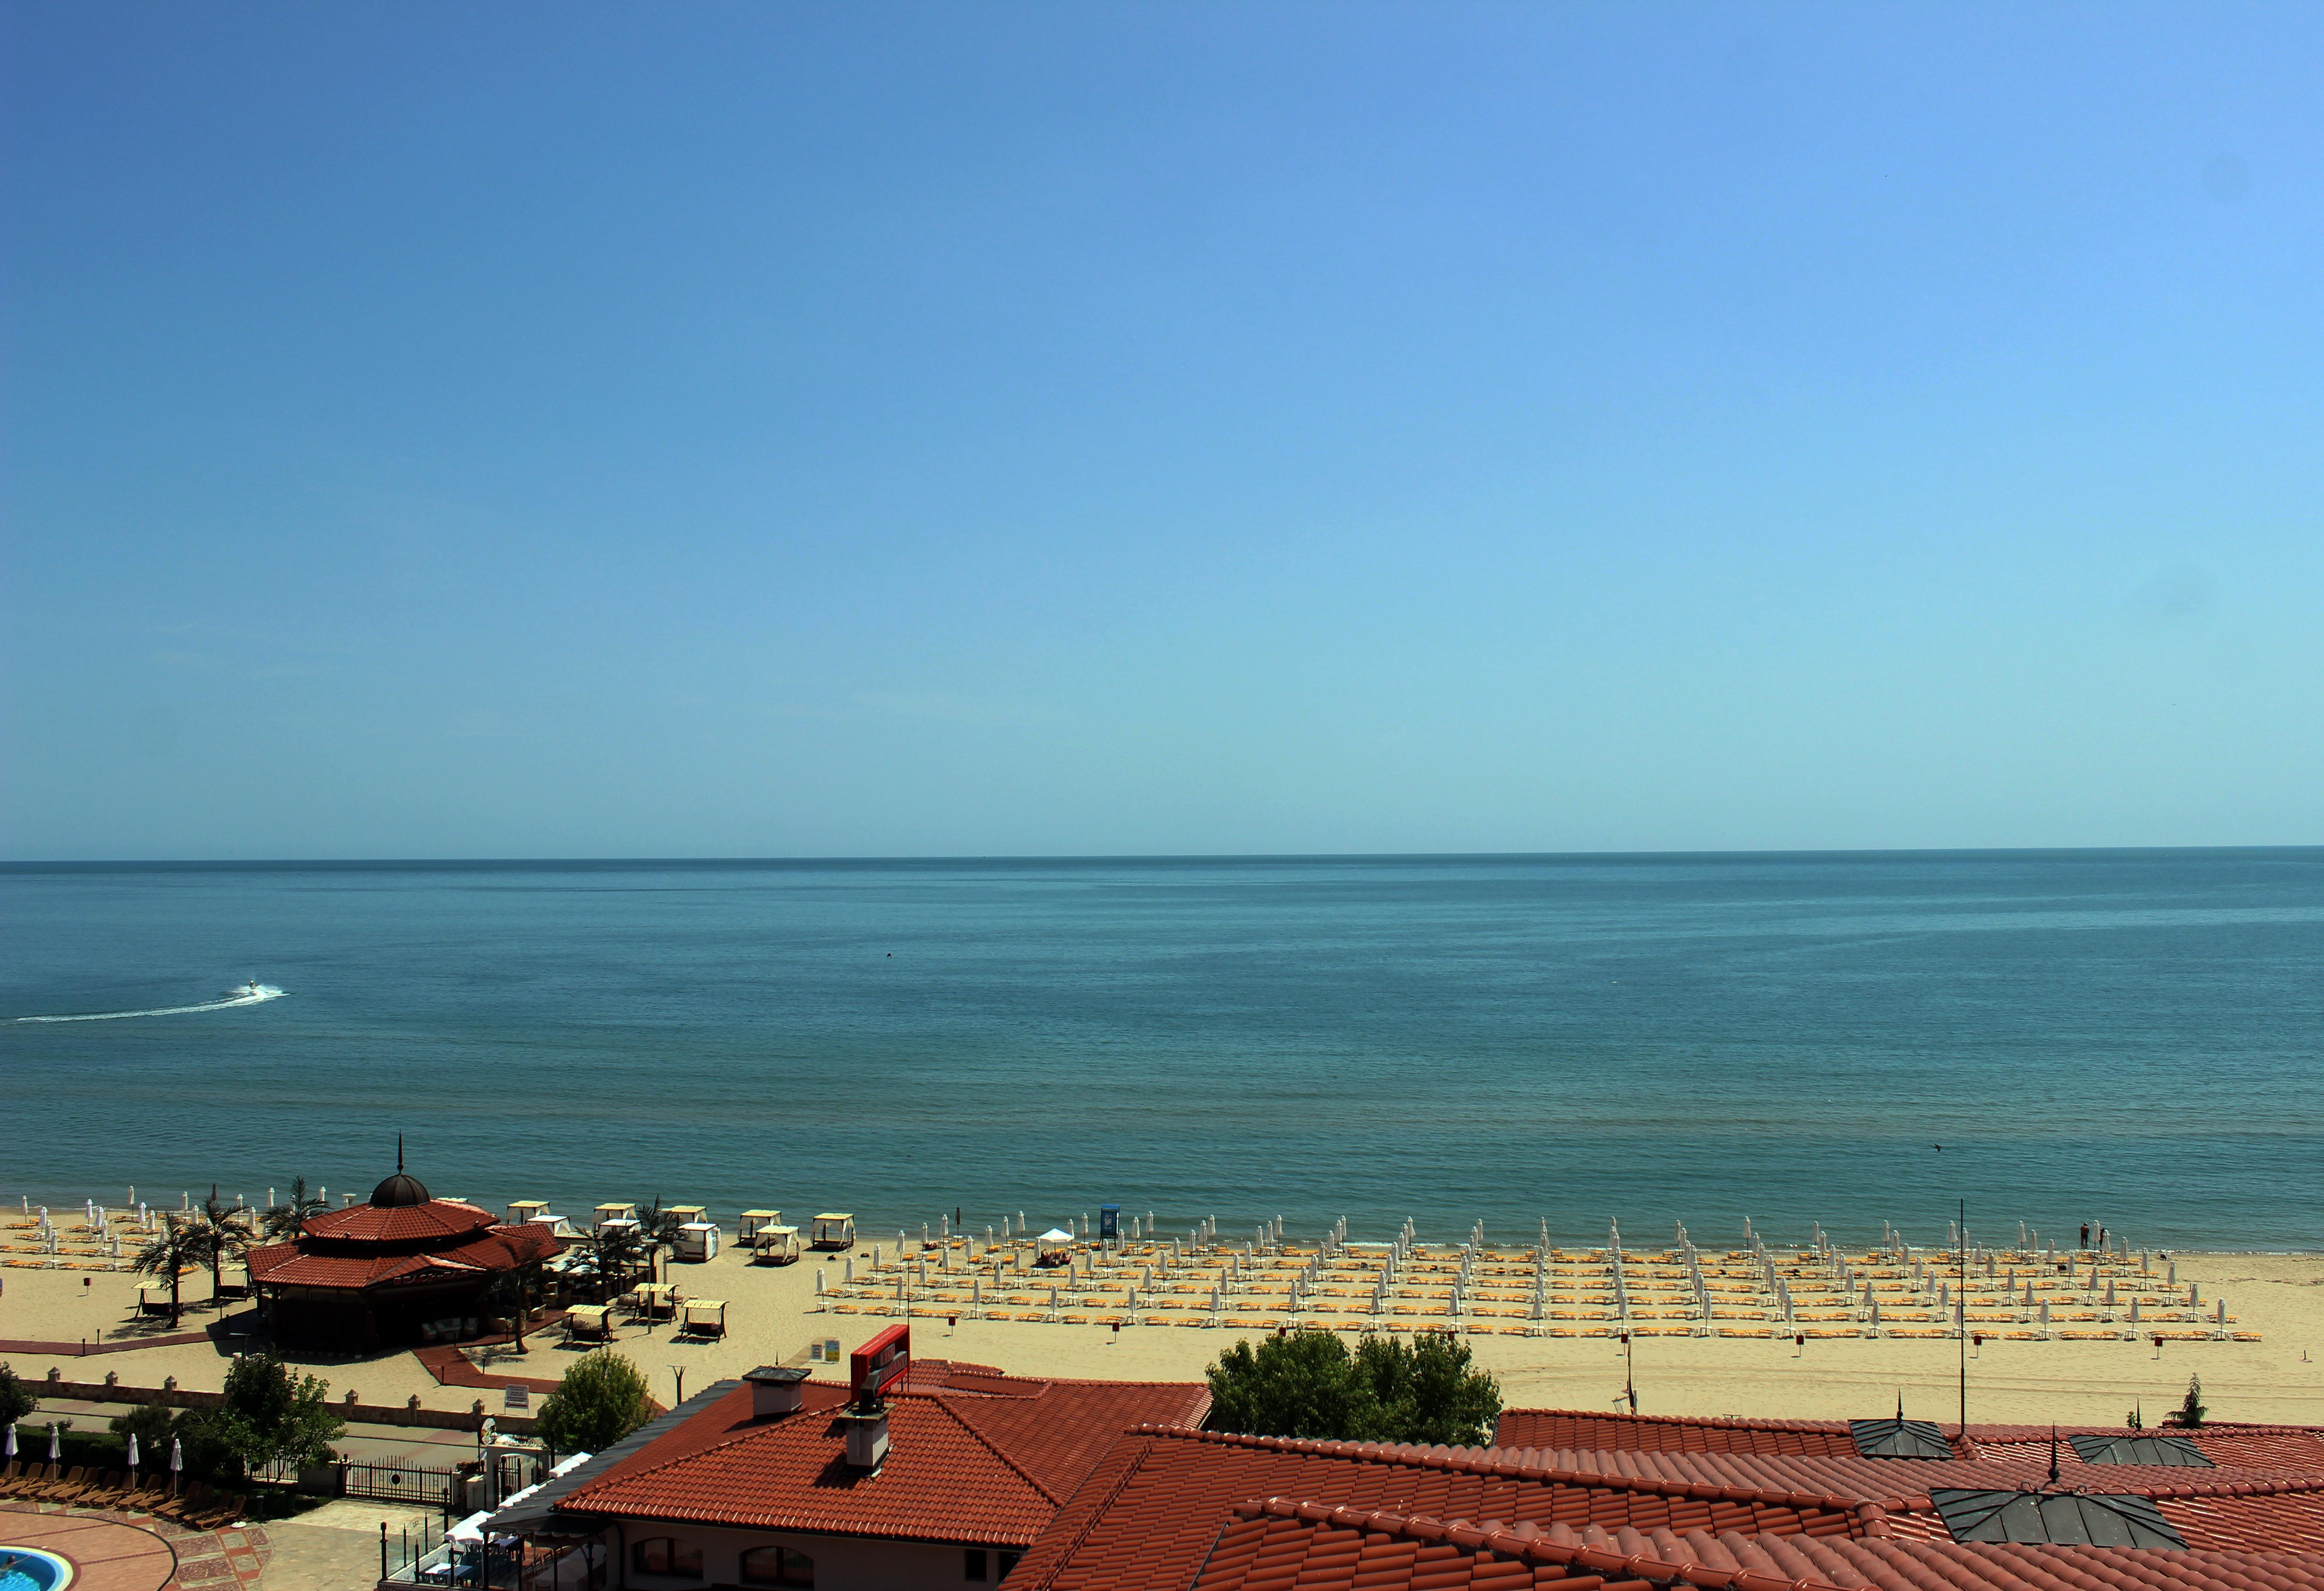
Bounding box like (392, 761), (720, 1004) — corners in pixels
(0, 0), (2324, 859)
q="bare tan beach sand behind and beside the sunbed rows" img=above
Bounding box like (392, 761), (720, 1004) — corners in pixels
(0, 1249), (2324, 1424)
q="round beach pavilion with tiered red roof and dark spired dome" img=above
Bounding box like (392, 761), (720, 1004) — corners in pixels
(249, 1152), (565, 1352)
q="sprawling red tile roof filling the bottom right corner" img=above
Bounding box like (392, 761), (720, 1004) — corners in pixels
(1006, 1410), (2324, 1591)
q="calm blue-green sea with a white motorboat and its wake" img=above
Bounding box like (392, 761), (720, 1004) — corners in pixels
(0, 850), (2324, 1249)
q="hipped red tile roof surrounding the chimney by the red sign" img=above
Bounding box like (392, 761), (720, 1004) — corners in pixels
(558, 1366), (1208, 1547)
